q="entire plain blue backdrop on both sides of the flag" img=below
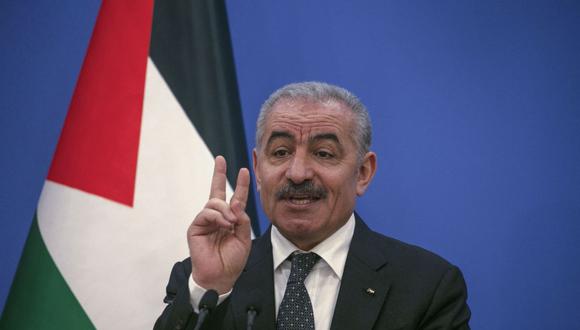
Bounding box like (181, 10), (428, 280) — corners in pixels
(0, 0), (580, 330)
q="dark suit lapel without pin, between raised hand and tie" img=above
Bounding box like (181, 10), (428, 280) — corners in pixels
(231, 229), (276, 329)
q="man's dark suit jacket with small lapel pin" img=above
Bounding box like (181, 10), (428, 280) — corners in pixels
(155, 216), (470, 330)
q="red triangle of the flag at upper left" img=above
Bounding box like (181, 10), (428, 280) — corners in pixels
(48, 0), (153, 206)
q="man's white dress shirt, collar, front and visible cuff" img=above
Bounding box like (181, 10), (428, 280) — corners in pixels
(189, 214), (355, 330)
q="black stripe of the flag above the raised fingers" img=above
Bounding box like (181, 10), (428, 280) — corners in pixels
(149, 0), (260, 236)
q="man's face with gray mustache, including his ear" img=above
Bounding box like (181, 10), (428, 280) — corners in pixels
(253, 100), (376, 250)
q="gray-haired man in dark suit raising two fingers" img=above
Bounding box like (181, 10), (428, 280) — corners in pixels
(155, 82), (470, 329)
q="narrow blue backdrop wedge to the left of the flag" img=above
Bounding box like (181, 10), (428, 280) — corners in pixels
(0, 0), (100, 318)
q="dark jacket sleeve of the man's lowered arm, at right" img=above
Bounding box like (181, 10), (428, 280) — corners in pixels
(420, 266), (471, 330)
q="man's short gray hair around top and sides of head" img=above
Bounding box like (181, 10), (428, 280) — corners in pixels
(256, 81), (372, 160)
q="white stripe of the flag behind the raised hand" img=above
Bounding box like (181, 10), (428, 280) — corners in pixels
(38, 60), (240, 330)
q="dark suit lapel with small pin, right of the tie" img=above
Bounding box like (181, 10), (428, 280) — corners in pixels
(331, 214), (390, 330)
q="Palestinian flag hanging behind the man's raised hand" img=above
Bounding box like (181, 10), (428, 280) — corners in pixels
(0, 0), (258, 330)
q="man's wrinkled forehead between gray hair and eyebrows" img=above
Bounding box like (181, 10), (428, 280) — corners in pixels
(265, 100), (353, 135)
